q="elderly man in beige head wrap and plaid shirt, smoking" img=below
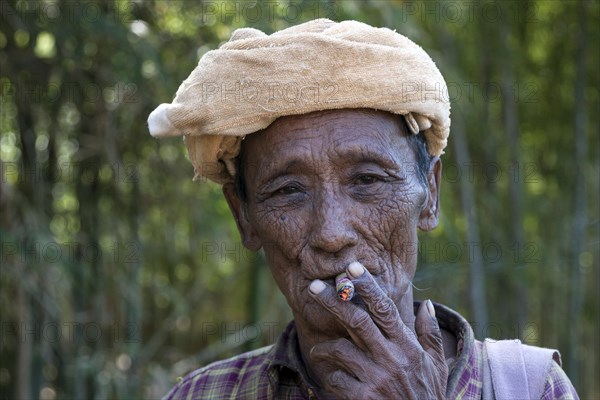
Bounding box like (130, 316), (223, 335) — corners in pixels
(148, 20), (577, 399)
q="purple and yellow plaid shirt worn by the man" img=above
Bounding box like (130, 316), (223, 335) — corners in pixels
(165, 304), (579, 400)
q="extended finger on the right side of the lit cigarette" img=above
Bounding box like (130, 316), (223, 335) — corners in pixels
(347, 262), (416, 344)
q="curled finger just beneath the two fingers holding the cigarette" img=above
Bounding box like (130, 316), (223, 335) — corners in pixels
(310, 338), (373, 382)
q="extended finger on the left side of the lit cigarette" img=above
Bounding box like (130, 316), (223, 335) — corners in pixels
(309, 279), (384, 350)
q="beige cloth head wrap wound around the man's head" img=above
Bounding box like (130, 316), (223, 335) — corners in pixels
(148, 19), (450, 183)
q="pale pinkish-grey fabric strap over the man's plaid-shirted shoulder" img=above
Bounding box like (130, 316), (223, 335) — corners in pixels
(483, 339), (560, 400)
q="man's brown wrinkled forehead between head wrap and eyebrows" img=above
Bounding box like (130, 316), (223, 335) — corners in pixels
(241, 110), (411, 184)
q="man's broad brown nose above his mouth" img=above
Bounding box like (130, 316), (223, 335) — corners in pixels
(310, 195), (358, 254)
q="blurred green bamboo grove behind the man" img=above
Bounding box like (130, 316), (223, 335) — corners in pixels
(0, 0), (600, 399)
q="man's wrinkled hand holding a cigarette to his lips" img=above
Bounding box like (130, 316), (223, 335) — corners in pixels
(310, 262), (448, 399)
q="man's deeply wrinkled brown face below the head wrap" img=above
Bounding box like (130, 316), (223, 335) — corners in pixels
(226, 110), (437, 336)
